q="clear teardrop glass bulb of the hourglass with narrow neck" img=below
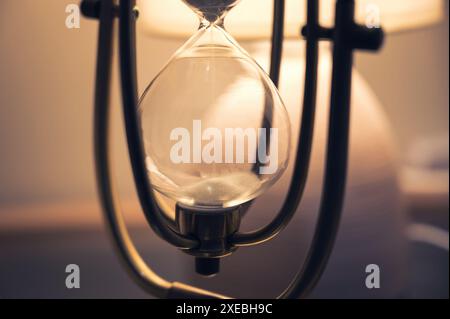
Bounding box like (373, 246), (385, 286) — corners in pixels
(139, 0), (290, 207)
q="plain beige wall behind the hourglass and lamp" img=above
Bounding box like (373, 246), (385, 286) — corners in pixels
(0, 0), (449, 205)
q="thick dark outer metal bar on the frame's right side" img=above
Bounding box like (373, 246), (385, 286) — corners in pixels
(281, 0), (355, 298)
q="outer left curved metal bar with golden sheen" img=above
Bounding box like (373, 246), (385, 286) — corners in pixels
(94, 0), (170, 297)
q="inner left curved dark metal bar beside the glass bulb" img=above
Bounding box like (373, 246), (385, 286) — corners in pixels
(119, 0), (198, 249)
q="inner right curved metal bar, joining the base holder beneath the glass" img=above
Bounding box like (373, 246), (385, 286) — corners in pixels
(230, 0), (319, 246)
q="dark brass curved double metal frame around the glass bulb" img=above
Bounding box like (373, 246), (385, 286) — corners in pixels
(81, 0), (383, 299)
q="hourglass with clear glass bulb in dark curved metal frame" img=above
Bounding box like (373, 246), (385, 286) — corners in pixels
(82, 0), (383, 298)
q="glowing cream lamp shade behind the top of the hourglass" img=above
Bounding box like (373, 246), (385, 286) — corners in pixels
(138, 0), (445, 40)
